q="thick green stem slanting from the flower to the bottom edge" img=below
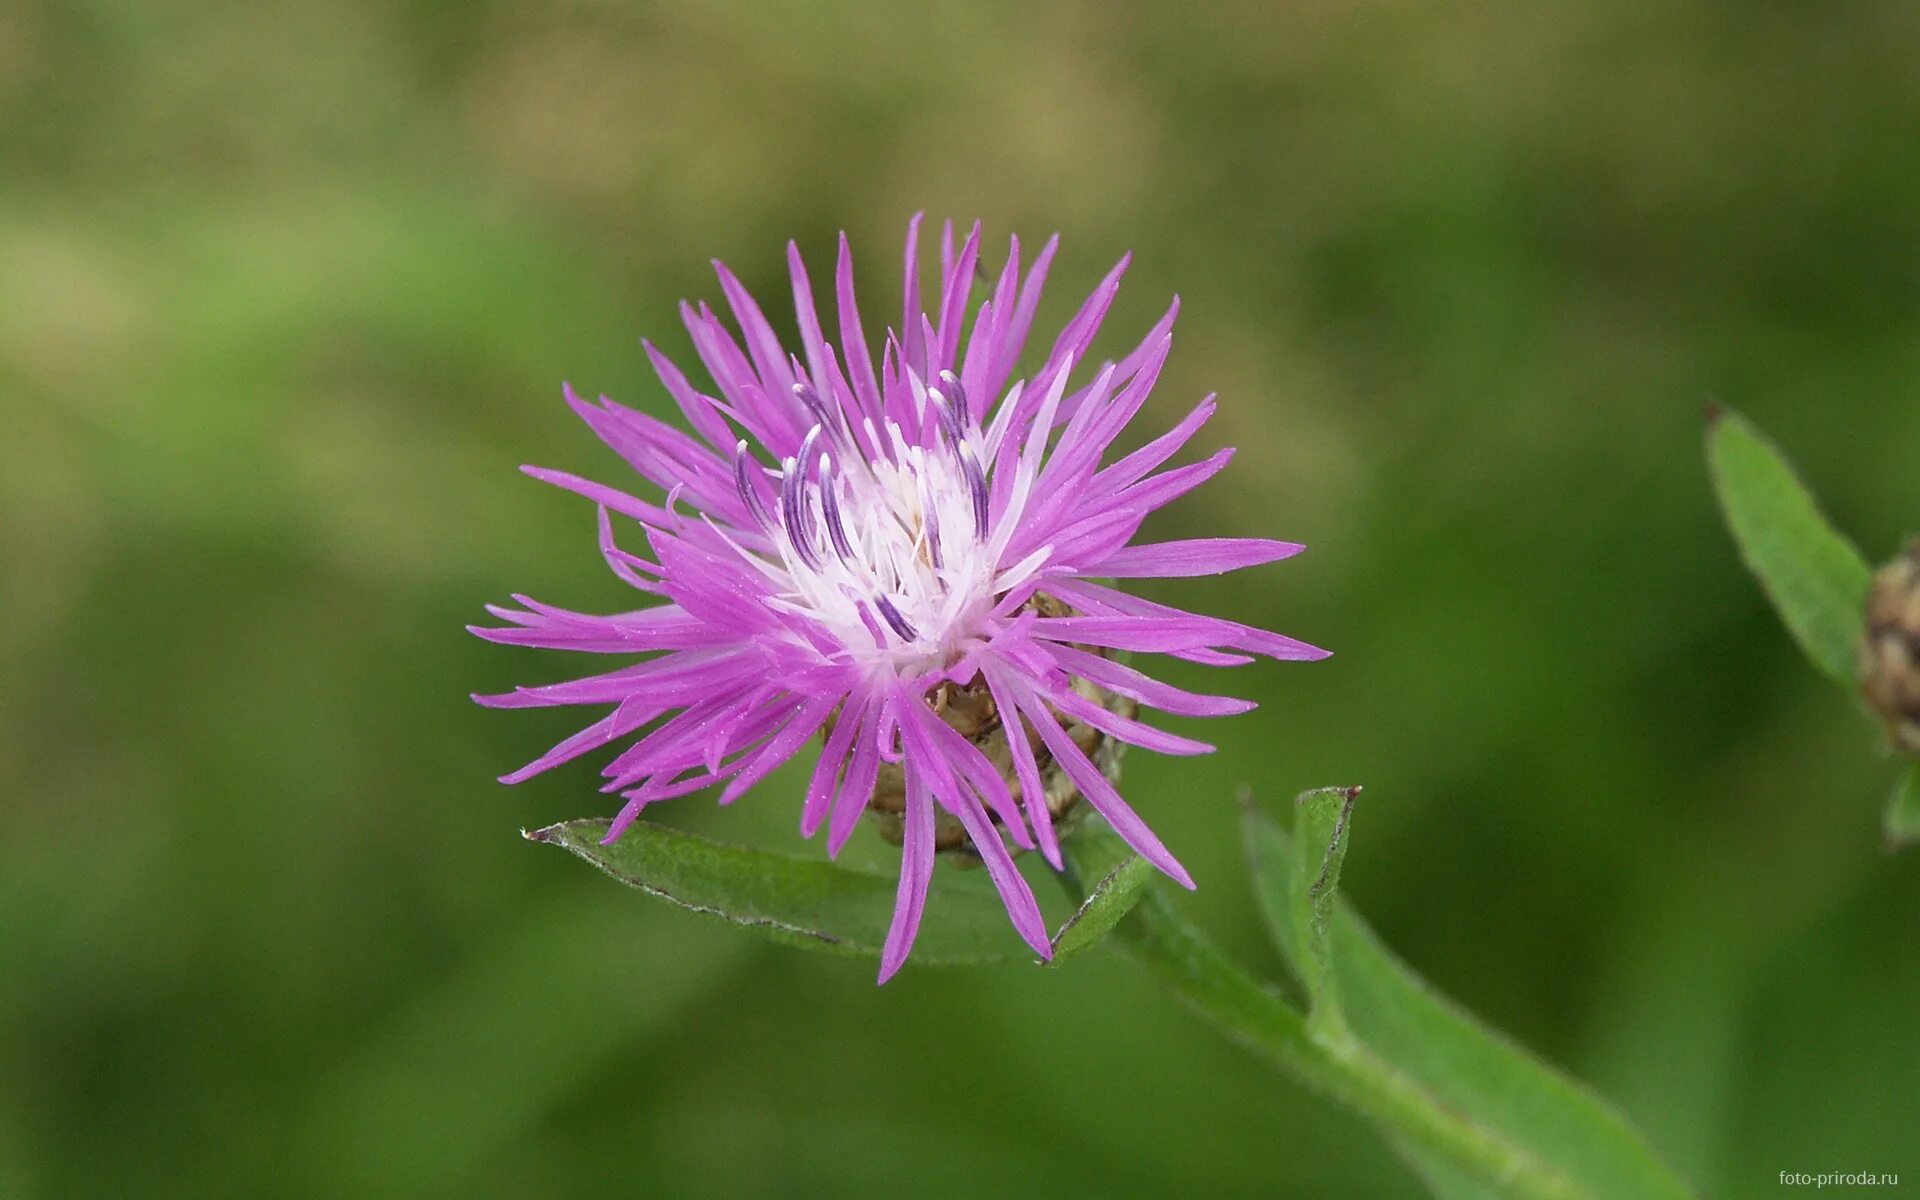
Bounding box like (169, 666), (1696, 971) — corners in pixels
(1117, 885), (1599, 1200)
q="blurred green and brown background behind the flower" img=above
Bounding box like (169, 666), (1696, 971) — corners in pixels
(0, 0), (1920, 1200)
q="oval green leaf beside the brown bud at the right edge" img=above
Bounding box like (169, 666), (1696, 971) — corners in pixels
(1707, 411), (1872, 689)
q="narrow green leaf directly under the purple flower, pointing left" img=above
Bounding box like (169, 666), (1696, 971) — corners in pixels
(522, 820), (1033, 966)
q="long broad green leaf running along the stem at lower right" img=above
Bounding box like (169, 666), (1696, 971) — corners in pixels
(1246, 793), (1688, 1200)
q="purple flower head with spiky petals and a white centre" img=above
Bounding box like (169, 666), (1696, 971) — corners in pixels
(474, 217), (1325, 981)
